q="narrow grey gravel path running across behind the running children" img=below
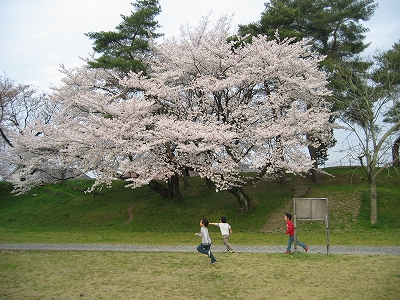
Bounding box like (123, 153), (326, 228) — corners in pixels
(0, 244), (400, 255)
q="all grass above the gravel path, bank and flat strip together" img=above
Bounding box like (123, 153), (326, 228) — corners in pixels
(0, 167), (400, 245)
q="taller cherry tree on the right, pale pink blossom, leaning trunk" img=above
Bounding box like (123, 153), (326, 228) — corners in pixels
(123, 17), (331, 210)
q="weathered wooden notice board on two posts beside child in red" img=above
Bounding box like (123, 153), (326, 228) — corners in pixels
(293, 198), (329, 255)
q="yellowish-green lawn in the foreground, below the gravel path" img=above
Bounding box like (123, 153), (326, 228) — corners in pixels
(0, 251), (400, 300)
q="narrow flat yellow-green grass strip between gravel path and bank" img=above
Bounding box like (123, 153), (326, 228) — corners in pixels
(0, 227), (400, 248)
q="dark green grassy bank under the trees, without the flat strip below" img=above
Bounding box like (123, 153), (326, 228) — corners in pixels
(0, 167), (400, 244)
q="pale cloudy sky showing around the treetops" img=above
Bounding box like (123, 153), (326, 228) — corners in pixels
(0, 0), (400, 164)
